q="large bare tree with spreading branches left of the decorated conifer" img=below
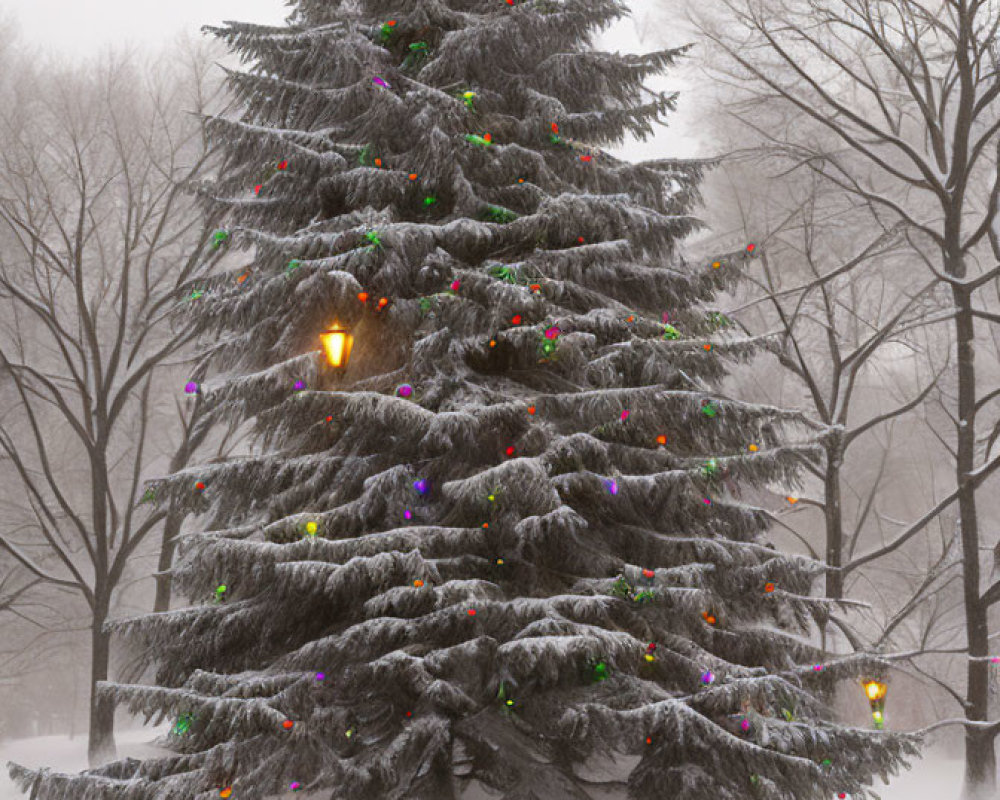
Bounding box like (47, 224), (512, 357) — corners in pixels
(0, 40), (227, 764)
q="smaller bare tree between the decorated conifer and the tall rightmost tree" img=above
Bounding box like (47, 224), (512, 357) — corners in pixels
(725, 172), (948, 620)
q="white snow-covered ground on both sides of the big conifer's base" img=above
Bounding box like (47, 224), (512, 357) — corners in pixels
(0, 726), (962, 800)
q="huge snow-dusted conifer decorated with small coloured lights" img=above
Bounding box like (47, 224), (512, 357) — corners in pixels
(14, 0), (912, 800)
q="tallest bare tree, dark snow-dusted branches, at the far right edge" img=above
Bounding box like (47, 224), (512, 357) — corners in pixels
(700, 0), (1000, 799)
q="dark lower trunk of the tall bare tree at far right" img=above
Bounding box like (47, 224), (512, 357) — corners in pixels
(953, 287), (997, 800)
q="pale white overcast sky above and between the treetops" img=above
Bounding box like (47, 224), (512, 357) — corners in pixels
(0, 0), (699, 160)
